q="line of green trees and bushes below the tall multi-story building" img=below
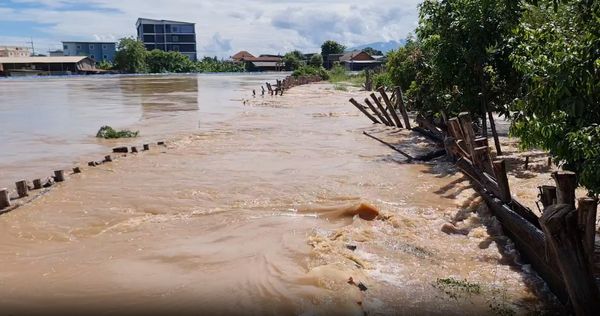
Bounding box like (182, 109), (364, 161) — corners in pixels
(112, 38), (245, 73)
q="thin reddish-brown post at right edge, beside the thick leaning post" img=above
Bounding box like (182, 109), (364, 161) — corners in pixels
(577, 197), (598, 269)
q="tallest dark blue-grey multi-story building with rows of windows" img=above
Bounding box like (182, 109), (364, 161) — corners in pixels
(136, 18), (197, 60)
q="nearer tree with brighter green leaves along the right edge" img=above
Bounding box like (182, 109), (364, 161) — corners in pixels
(511, 0), (600, 195)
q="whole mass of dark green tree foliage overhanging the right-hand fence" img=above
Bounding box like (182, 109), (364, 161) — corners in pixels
(376, 0), (600, 195)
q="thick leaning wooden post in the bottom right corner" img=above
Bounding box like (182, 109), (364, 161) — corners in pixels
(540, 204), (600, 315)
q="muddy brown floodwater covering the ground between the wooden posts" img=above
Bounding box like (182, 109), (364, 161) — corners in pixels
(0, 76), (555, 315)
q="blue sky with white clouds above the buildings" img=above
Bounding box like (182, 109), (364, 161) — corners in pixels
(0, 0), (421, 58)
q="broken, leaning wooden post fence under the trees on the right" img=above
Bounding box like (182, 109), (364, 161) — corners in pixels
(350, 88), (600, 315)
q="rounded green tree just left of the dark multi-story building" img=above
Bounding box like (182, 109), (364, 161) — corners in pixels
(115, 37), (148, 73)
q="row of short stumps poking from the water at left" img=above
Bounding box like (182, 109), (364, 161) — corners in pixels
(0, 141), (165, 212)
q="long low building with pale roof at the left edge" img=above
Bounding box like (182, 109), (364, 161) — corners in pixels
(0, 56), (99, 76)
